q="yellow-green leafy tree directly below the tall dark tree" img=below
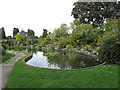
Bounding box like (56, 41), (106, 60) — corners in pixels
(70, 24), (102, 46)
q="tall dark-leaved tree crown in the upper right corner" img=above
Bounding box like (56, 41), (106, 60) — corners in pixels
(72, 1), (120, 27)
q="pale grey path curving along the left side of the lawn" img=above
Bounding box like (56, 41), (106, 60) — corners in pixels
(0, 51), (26, 90)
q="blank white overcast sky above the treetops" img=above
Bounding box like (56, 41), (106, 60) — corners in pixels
(0, 0), (78, 36)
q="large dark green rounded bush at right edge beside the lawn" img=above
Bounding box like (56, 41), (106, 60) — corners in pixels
(98, 36), (120, 64)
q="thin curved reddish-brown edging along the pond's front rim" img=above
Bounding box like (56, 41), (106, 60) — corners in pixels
(23, 55), (106, 71)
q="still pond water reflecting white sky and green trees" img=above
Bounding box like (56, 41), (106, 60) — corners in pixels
(26, 51), (100, 69)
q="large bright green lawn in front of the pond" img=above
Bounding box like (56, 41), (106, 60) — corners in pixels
(7, 54), (118, 88)
